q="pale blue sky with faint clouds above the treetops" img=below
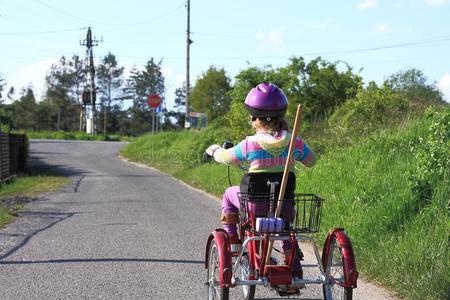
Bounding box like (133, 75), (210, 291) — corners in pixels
(0, 0), (450, 105)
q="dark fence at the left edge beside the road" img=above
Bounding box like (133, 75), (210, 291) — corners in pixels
(0, 133), (27, 182)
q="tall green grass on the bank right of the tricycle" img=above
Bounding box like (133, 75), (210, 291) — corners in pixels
(298, 118), (450, 299)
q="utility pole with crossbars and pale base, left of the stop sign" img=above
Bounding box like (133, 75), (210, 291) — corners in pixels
(80, 27), (102, 135)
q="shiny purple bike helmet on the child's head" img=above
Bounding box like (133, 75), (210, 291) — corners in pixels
(245, 83), (287, 117)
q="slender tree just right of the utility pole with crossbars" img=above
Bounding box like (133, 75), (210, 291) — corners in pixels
(97, 52), (125, 134)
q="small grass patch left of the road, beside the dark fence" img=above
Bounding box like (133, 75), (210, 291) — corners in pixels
(0, 173), (69, 228)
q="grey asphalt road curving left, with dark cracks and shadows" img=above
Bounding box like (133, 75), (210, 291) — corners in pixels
(0, 140), (394, 299)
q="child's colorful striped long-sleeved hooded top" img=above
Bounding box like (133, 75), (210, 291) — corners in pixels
(214, 130), (316, 173)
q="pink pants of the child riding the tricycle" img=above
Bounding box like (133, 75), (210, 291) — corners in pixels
(222, 186), (292, 251)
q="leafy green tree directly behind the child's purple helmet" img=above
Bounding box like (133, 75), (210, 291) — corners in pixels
(226, 57), (362, 139)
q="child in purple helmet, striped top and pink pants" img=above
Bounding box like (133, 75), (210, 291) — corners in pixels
(206, 83), (316, 276)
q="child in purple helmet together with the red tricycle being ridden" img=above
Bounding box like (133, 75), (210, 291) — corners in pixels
(205, 83), (358, 299)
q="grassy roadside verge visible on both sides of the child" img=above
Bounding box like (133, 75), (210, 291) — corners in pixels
(122, 119), (450, 299)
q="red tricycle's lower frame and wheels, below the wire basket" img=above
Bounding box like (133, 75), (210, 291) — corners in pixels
(205, 193), (358, 300)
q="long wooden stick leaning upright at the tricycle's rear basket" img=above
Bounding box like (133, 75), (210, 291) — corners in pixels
(266, 104), (302, 265)
